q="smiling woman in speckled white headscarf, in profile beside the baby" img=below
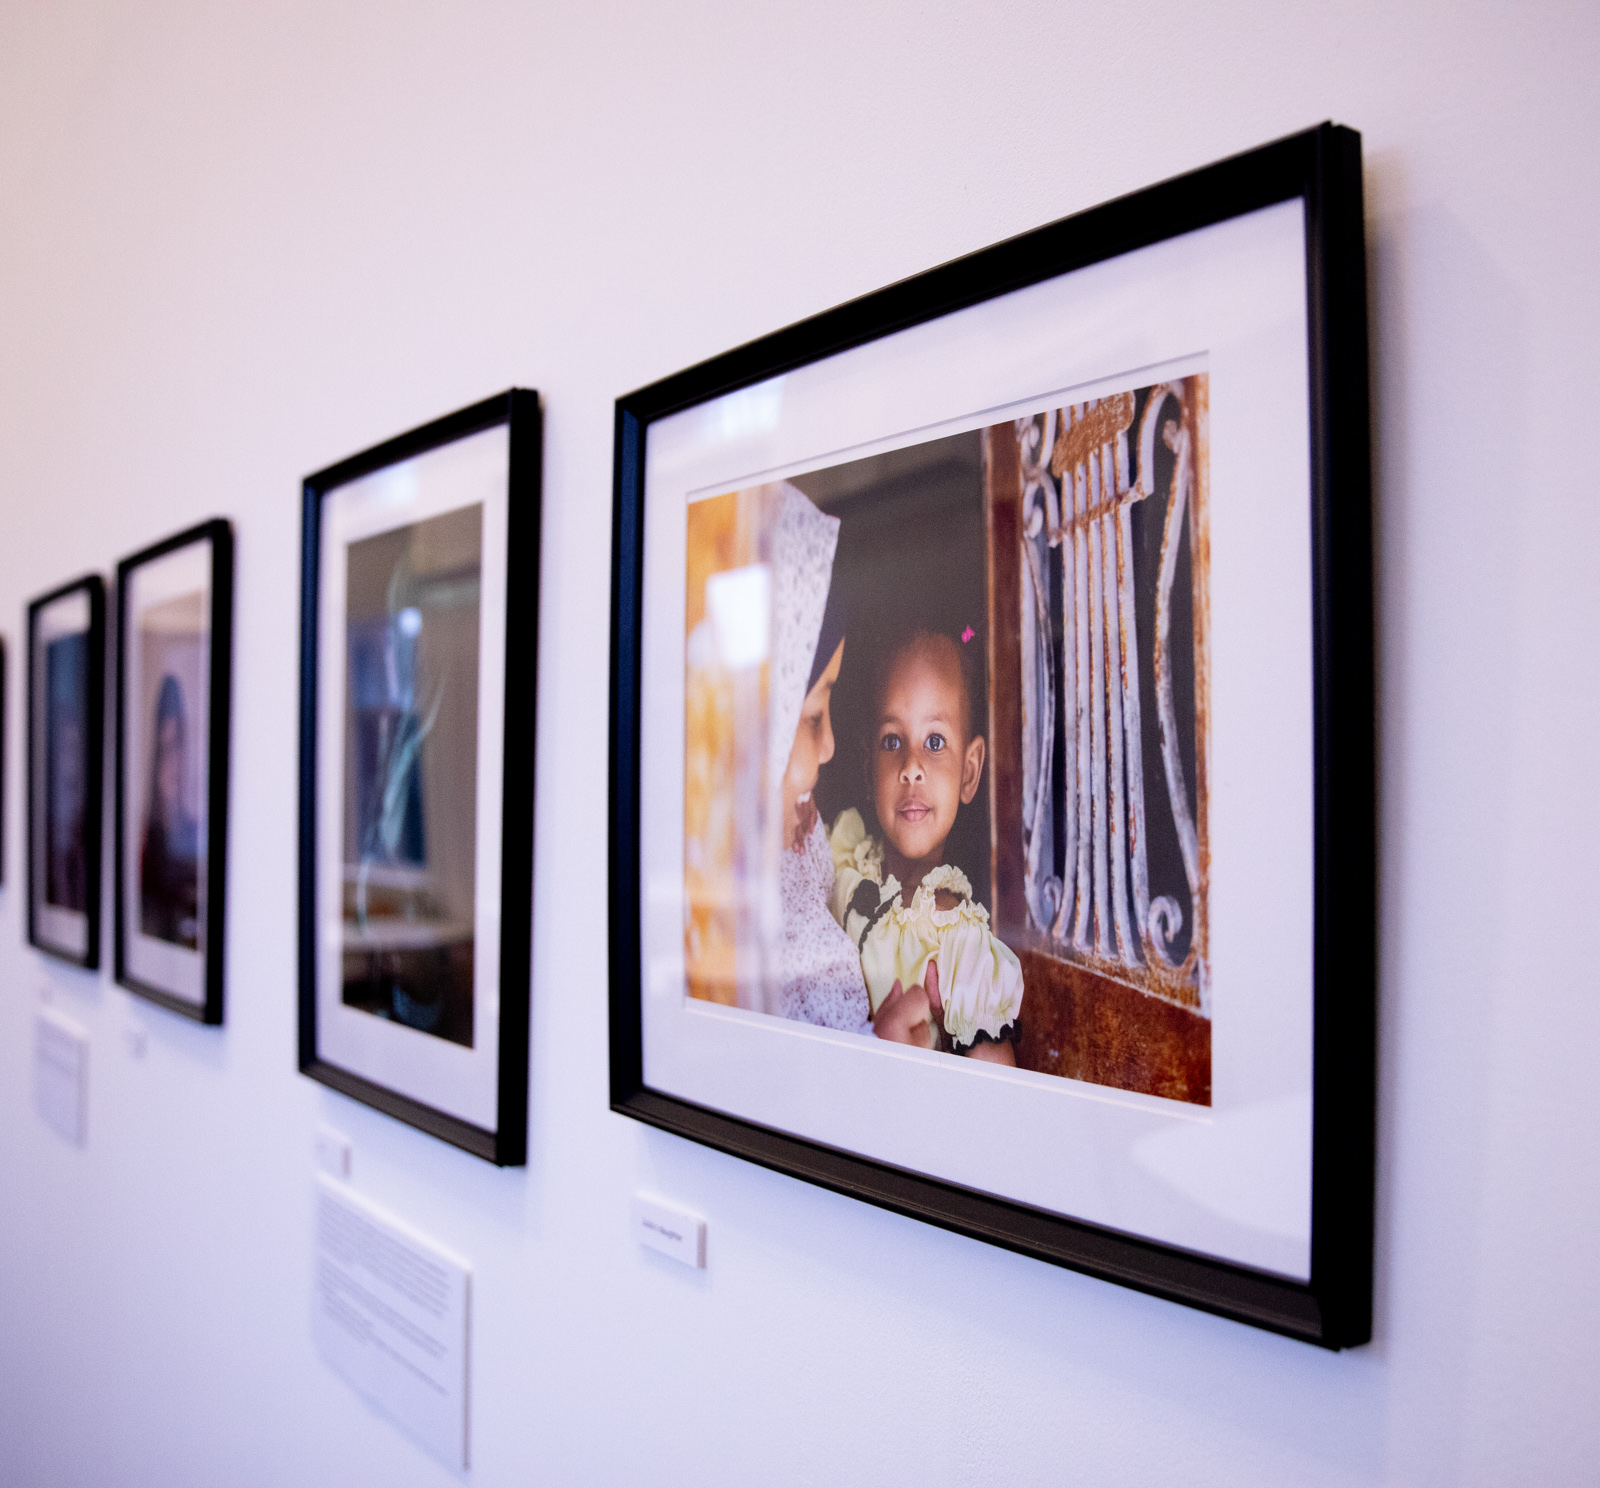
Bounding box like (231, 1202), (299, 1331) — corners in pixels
(766, 482), (872, 1034)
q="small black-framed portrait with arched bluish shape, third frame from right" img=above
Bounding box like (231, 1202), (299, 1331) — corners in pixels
(114, 518), (234, 1022)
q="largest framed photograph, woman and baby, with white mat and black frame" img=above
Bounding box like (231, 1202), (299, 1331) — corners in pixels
(610, 125), (1374, 1347)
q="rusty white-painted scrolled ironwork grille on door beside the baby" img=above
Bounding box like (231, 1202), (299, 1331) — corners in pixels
(1014, 382), (1210, 1011)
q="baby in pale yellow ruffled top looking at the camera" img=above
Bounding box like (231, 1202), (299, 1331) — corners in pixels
(829, 630), (1022, 1064)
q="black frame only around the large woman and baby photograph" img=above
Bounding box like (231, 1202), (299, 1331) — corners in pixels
(610, 123), (1376, 1349)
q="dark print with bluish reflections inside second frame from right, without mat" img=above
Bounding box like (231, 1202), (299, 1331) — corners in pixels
(344, 504), (483, 1046)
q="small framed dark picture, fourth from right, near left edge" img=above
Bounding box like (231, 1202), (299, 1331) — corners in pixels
(27, 574), (106, 968)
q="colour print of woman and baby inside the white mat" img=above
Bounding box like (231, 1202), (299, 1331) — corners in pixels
(685, 373), (1211, 1104)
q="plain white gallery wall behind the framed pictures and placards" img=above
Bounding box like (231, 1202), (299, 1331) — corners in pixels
(0, 0), (1600, 1485)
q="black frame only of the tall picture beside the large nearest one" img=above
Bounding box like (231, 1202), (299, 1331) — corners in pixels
(299, 387), (542, 1166)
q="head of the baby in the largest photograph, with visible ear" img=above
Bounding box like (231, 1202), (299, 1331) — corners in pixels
(872, 638), (984, 866)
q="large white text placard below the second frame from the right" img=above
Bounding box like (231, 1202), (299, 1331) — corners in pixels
(312, 1178), (472, 1467)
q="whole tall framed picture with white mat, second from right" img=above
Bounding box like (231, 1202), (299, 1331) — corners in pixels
(299, 389), (541, 1165)
